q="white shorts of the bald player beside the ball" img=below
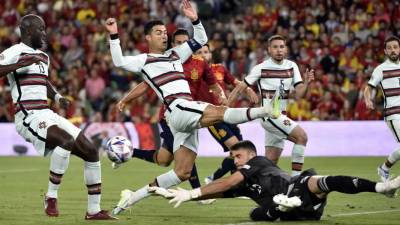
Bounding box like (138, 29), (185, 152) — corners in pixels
(15, 109), (81, 156)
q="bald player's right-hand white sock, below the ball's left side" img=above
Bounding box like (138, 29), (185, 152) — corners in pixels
(84, 161), (101, 214)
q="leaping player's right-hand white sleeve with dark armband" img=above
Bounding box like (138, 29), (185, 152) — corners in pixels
(171, 20), (208, 63)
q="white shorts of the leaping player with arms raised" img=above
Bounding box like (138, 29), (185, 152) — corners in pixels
(165, 99), (209, 154)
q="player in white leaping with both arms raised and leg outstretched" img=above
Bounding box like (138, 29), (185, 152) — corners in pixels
(105, 0), (280, 214)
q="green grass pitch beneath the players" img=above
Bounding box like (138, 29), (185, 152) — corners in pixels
(0, 157), (400, 225)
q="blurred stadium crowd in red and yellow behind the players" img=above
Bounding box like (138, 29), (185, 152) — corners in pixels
(0, 0), (400, 124)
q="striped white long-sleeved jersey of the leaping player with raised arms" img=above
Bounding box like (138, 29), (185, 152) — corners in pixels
(110, 23), (207, 110)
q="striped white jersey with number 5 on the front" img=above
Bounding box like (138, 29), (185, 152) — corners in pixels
(244, 58), (303, 111)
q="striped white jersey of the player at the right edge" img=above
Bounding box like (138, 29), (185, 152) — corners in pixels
(368, 59), (400, 120)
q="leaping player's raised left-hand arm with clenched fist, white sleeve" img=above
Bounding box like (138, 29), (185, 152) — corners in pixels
(104, 18), (146, 72)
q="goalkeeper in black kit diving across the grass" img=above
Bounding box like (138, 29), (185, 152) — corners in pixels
(149, 141), (400, 221)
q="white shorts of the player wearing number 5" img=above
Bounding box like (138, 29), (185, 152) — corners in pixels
(261, 115), (298, 149)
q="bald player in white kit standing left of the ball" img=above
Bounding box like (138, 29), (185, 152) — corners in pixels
(0, 14), (116, 220)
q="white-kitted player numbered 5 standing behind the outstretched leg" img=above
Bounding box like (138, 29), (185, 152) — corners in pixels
(228, 35), (314, 176)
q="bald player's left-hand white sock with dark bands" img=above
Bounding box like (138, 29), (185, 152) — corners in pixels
(46, 146), (71, 198)
